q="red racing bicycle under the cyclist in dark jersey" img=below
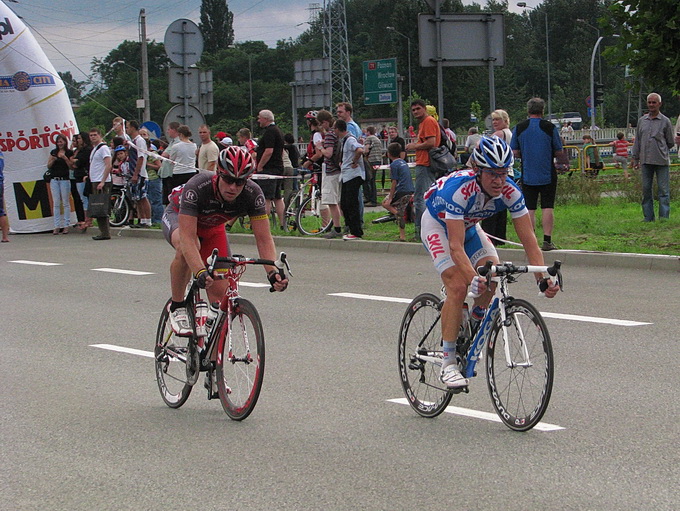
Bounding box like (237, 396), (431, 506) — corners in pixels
(154, 249), (290, 420)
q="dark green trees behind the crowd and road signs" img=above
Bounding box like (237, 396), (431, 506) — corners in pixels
(65, 0), (680, 138)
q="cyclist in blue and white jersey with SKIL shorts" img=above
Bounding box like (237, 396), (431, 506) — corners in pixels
(421, 136), (559, 388)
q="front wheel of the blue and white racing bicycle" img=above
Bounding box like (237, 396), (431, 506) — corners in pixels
(486, 300), (555, 431)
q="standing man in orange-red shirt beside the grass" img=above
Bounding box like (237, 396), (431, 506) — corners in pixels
(406, 99), (441, 240)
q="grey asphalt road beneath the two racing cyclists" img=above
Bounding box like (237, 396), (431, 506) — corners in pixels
(0, 234), (680, 510)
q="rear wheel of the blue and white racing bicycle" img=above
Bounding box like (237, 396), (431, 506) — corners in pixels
(399, 293), (451, 417)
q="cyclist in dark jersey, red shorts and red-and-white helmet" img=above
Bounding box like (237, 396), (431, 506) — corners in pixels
(162, 146), (288, 335)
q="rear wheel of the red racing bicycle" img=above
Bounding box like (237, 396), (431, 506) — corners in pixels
(154, 300), (198, 408)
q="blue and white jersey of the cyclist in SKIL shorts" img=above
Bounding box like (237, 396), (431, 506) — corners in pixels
(425, 169), (529, 229)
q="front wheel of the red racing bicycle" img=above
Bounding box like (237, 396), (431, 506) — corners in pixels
(216, 298), (264, 421)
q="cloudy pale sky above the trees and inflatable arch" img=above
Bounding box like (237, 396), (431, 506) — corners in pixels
(2, 0), (540, 85)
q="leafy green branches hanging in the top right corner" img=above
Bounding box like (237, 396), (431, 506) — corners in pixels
(609, 0), (680, 94)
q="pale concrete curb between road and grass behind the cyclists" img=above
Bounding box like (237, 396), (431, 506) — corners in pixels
(111, 227), (680, 272)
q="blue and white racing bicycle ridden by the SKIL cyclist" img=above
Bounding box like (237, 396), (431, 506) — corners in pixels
(399, 261), (562, 431)
